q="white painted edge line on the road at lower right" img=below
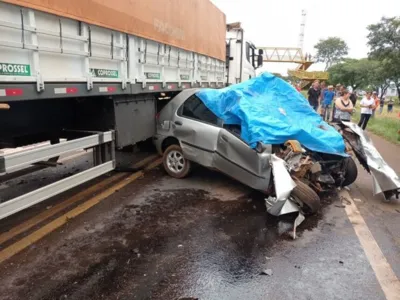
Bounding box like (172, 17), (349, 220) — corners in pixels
(340, 190), (400, 300)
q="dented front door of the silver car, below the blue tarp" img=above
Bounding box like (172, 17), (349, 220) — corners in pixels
(214, 128), (271, 191)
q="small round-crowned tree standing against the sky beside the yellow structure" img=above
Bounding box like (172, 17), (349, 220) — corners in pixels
(314, 37), (349, 71)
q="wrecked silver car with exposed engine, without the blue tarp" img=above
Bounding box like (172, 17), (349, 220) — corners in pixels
(154, 89), (357, 215)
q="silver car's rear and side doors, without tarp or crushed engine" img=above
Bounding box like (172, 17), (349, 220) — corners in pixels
(154, 89), (272, 191)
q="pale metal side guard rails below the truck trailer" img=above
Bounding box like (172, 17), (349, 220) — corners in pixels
(0, 131), (115, 220)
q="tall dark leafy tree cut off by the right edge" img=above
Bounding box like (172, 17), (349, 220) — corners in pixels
(367, 17), (400, 96)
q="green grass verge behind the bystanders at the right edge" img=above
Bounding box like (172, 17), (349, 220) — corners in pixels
(353, 103), (400, 144)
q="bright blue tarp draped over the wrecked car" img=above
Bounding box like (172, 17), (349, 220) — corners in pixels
(196, 73), (346, 156)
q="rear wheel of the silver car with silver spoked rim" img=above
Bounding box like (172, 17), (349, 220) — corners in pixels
(163, 145), (192, 179)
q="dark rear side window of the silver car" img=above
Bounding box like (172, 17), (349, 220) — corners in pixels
(178, 95), (219, 126)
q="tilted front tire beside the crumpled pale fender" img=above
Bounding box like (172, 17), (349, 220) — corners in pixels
(291, 178), (321, 215)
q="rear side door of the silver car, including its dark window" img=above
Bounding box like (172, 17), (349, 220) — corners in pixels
(172, 95), (221, 167)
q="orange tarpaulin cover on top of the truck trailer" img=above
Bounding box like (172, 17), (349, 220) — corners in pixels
(3, 0), (226, 60)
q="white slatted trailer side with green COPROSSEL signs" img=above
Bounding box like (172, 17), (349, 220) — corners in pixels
(0, 0), (225, 95)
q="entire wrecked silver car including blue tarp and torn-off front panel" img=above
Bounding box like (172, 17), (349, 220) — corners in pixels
(154, 73), (400, 219)
